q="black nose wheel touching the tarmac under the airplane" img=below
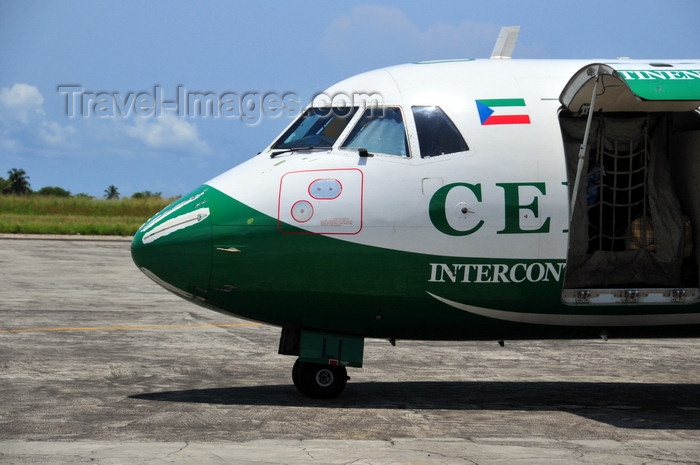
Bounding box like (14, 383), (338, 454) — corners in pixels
(292, 359), (350, 399)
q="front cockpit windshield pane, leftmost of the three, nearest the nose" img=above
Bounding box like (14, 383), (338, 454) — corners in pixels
(272, 107), (357, 149)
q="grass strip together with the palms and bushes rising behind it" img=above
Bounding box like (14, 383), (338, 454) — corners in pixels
(0, 168), (173, 236)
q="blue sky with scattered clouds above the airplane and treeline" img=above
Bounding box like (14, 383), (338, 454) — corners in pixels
(0, 0), (700, 197)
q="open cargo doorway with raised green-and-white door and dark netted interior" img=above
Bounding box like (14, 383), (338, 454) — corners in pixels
(559, 61), (700, 305)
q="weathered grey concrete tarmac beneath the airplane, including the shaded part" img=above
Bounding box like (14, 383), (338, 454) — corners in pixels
(0, 235), (700, 465)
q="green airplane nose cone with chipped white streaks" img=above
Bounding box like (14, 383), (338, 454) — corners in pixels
(131, 186), (212, 304)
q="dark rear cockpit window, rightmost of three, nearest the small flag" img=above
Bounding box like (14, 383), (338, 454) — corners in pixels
(411, 106), (469, 157)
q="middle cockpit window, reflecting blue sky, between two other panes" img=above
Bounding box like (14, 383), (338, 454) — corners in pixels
(342, 107), (409, 157)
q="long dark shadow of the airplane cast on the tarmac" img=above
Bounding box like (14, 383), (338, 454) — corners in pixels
(130, 381), (700, 429)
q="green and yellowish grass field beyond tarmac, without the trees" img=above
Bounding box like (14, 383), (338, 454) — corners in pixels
(0, 195), (173, 236)
